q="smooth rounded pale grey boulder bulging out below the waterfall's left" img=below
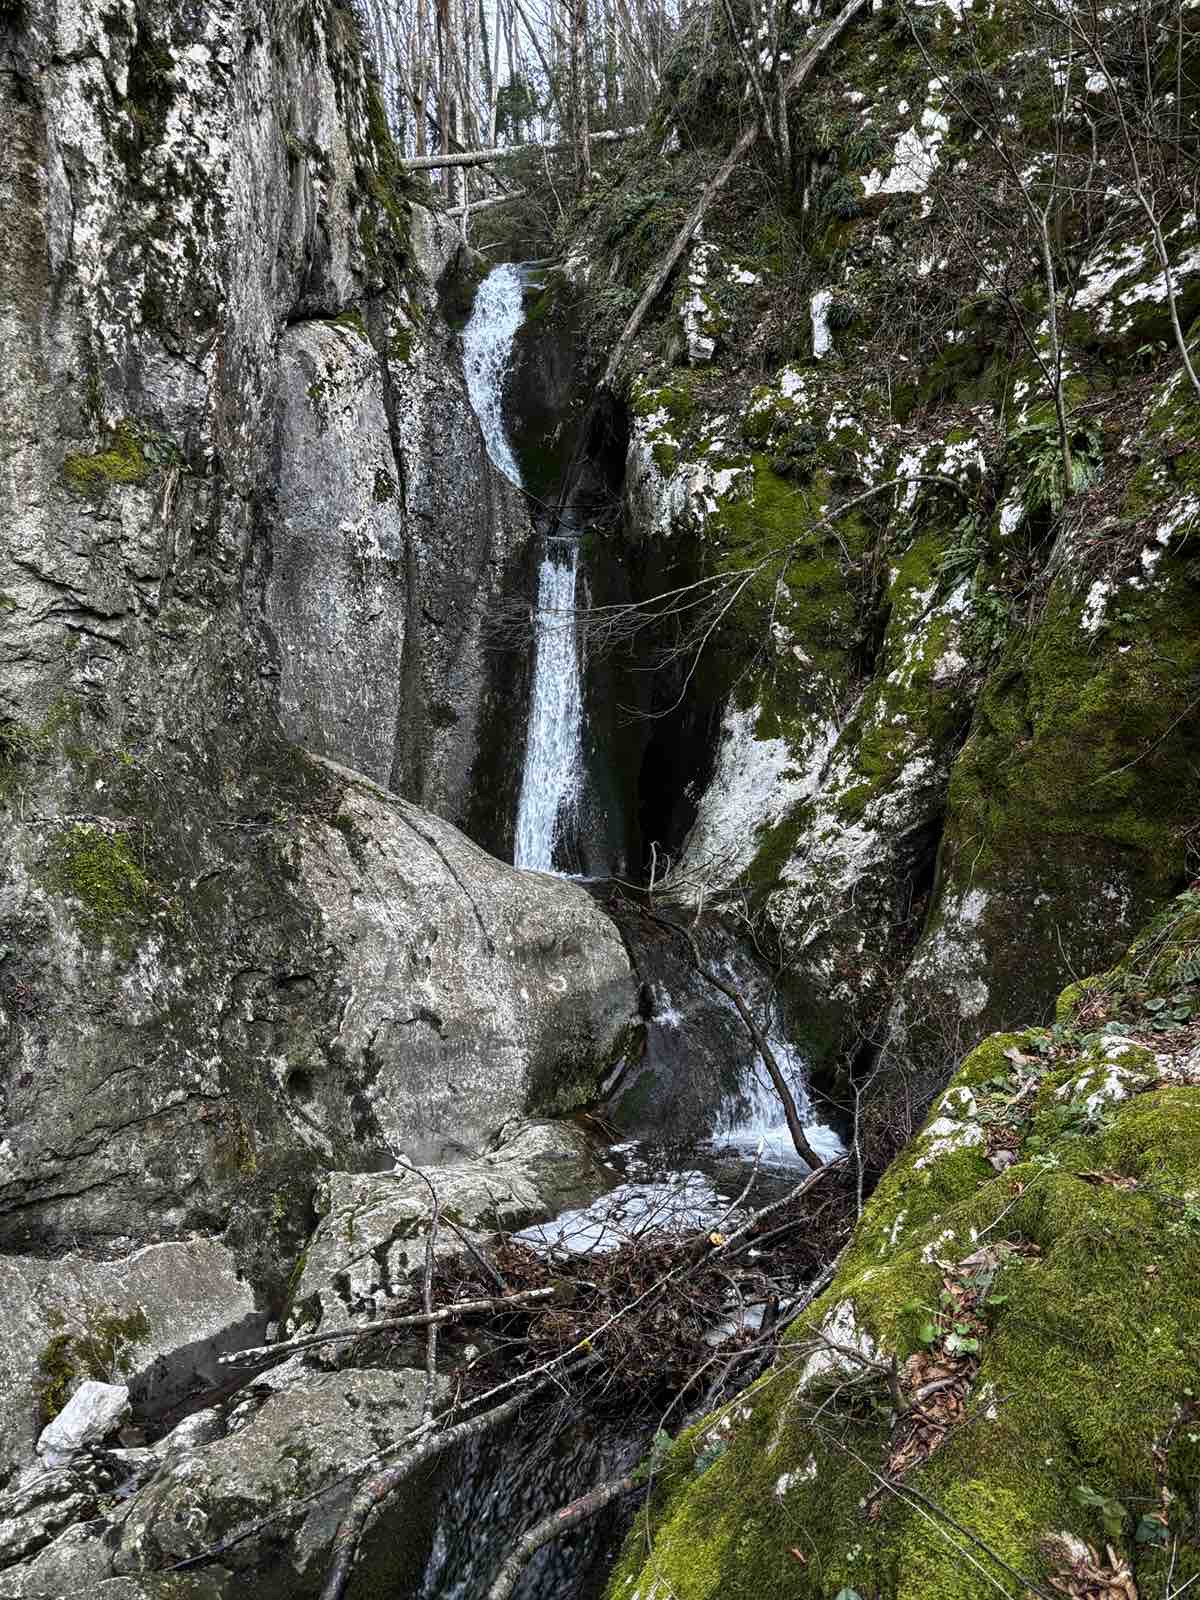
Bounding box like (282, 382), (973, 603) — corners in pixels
(299, 782), (634, 1160)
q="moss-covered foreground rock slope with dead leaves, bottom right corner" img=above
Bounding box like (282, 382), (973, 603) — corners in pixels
(608, 893), (1200, 1600)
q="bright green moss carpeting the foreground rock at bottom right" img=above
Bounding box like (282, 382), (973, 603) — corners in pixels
(620, 908), (1200, 1600)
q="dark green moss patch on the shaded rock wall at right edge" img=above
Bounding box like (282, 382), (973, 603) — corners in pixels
(930, 528), (1200, 1018)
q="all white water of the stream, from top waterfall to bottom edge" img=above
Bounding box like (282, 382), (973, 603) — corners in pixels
(438, 264), (842, 1600)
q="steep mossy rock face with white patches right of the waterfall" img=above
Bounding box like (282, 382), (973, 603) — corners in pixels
(570, 6), (1200, 1132)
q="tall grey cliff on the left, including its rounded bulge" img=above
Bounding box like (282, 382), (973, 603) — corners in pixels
(0, 0), (635, 1523)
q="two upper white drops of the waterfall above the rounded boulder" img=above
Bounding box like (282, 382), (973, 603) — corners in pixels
(462, 264), (584, 872)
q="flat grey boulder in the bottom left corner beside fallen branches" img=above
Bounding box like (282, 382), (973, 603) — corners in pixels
(0, 1363), (445, 1600)
